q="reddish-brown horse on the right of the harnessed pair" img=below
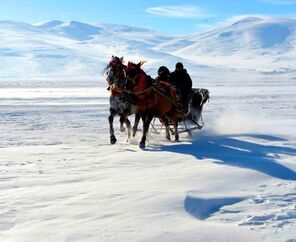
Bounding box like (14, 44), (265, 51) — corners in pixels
(126, 62), (184, 148)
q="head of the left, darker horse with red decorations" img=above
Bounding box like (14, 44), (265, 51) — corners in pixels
(105, 56), (126, 88)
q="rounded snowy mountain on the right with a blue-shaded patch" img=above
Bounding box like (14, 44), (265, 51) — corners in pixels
(164, 17), (296, 71)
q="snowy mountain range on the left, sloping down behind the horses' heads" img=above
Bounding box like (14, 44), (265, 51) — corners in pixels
(0, 20), (177, 84)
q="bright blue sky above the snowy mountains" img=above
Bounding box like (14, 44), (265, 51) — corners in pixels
(0, 0), (296, 34)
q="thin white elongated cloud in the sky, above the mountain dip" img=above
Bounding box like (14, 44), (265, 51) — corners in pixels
(146, 5), (209, 18)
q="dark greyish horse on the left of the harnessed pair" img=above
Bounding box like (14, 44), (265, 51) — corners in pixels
(104, 56), (135, 144)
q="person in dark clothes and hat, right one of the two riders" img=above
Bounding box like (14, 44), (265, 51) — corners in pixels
(170, 62), (192, 113)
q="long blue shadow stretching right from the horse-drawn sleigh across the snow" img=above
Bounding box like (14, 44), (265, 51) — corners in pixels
(150, 134), (296, 180)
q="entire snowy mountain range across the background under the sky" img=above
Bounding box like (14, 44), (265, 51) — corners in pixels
(0, 17), (296, 82)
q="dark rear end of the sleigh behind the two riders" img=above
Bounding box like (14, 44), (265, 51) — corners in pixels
(190, 88), (210, 123)
